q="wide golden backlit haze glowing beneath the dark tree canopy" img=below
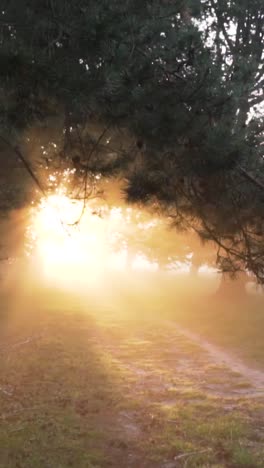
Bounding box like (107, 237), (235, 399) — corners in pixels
(0, 160), (262, 318)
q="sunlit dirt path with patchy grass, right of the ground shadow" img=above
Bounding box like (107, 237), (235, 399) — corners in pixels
(85, 315), (264, 468)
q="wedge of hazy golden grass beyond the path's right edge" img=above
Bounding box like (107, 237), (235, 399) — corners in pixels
(166, 296), (264, 369)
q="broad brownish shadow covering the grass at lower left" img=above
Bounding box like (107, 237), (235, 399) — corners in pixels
(0, 290), (129, 468)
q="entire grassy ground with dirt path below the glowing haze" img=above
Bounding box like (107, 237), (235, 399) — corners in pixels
(0, 291), (264, 468)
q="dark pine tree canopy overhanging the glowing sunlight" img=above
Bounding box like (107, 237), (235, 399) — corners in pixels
(0, 0), (264, 283)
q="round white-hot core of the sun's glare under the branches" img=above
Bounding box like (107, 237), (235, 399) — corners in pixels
(28, 193), (106, 284)
